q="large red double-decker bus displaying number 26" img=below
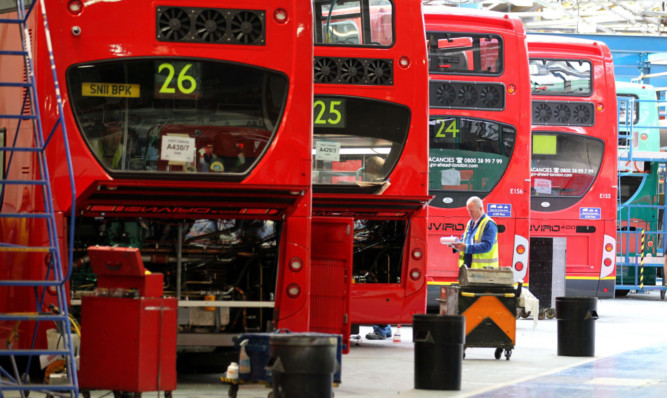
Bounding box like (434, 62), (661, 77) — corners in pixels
(0, 0), (313, 351)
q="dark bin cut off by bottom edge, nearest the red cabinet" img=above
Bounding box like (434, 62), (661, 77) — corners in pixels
(267, 333), (340, 398)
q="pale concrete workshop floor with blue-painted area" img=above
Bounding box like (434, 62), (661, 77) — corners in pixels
(162, 291), (667, 398)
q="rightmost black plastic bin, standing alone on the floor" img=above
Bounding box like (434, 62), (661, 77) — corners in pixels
(556, 297), (598, 357)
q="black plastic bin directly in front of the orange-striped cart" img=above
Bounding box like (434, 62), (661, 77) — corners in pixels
(412, 314), (465, 390)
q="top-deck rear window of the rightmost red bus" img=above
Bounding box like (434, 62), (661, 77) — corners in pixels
(530, 58), (593, 97)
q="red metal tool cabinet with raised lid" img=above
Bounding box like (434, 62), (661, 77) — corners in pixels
(79, 247), (178, 393)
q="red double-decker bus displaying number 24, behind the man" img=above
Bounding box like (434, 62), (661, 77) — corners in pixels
(424, 6), (530, 311)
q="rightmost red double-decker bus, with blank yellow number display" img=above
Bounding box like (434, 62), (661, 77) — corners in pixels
(528, 35), (618, 316)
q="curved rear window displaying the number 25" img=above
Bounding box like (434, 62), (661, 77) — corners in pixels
(313, 96), (410, 188)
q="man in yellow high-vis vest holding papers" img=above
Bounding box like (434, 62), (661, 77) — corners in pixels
(452, 196), (499, 268)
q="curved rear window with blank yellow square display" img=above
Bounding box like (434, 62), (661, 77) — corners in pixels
(531, 132), (604, 198)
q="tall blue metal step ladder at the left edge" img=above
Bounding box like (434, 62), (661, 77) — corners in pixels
(0, 0), (79, 398)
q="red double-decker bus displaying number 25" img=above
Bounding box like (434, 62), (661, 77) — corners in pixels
(312, 0), (428, 325)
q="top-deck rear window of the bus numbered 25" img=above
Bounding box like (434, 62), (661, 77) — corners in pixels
(313, 0), (394, 46)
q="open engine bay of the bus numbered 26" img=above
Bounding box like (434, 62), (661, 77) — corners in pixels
(71, 218), (282, 347)
